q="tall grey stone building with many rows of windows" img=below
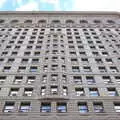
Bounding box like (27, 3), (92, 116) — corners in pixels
(0, 12), (120, 120)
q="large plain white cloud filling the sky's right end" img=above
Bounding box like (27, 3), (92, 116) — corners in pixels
(72, 0), (120, 11)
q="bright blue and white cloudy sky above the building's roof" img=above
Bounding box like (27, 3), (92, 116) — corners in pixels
(0, 0), (120, 12)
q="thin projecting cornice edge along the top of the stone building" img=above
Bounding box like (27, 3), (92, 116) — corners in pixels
(0, 11), (120, 16)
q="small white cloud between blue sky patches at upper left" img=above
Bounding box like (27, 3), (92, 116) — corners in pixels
(16, 1), (39, 11)
